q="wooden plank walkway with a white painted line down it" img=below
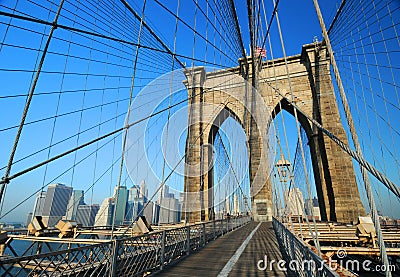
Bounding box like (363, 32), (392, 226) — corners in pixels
(156, 222), (296, 277)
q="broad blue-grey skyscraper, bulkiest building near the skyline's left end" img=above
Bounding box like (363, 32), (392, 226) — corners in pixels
(42, 184), (72, 227)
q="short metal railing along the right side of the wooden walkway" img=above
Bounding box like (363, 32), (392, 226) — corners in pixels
(272, 218), (339, 277)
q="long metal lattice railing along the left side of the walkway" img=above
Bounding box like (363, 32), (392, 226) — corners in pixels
(0, 217), (250, 276)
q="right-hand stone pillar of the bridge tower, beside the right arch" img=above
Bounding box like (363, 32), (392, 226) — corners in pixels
(302, 46), (365, 222)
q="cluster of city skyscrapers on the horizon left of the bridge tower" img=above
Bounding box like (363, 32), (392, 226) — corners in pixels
(25, 180), (191, 227)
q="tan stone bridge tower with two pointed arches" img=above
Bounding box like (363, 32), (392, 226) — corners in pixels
(183, 44), (365, 222)
